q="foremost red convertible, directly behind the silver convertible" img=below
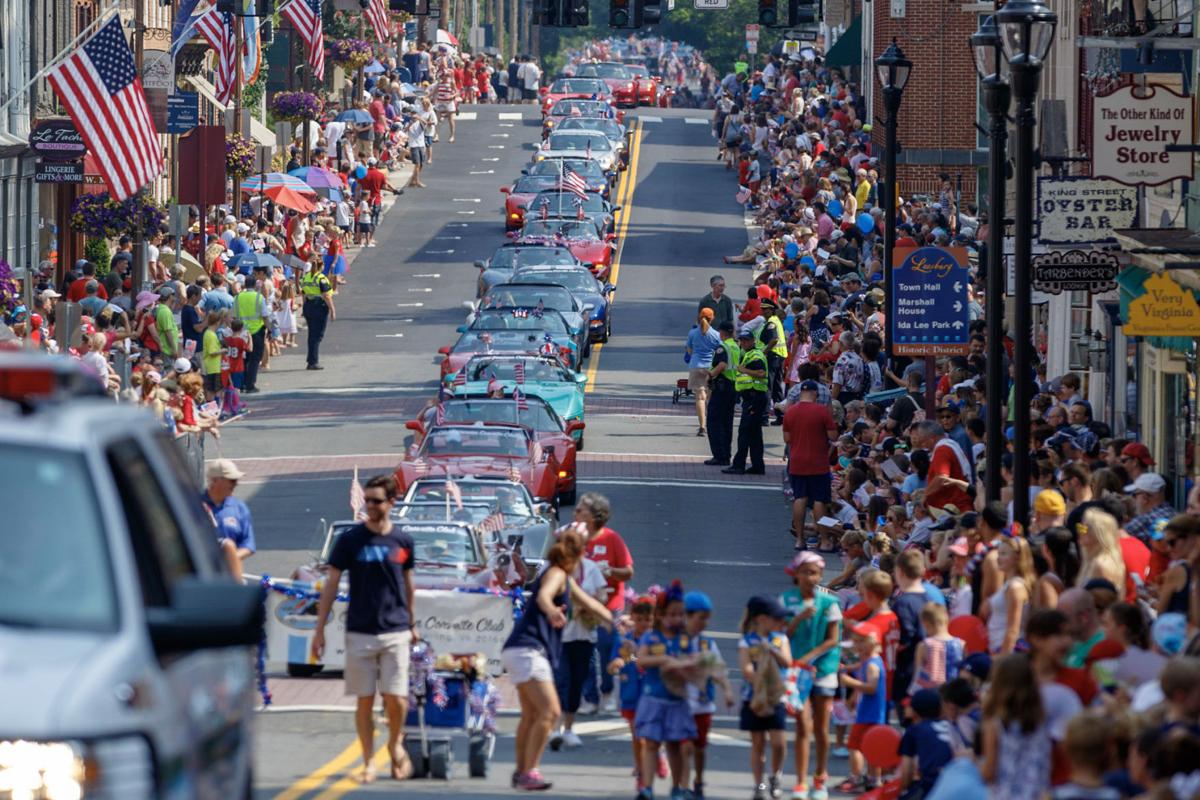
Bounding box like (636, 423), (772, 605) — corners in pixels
(395, 422), (559, 506)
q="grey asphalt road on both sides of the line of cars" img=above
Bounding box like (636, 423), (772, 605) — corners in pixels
(220, 106), (820, 800)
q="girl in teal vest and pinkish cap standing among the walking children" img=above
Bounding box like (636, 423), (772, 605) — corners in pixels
(779, 551), (841, 800)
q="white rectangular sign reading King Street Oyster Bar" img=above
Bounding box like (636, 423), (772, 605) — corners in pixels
(1038, 178), (1138, 245)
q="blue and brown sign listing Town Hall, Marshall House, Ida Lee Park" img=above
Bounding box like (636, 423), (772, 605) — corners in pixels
(888, 247), (971, 355)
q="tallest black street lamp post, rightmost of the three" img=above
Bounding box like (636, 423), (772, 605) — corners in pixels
(988, 0), (1058, 530)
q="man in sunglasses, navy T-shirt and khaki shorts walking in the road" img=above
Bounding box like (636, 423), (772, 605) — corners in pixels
(312, 475), (418, 783)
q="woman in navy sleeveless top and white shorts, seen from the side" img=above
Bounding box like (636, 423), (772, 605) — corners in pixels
(500, 530), (612, 792)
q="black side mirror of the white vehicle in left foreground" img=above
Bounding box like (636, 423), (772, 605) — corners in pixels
(146, 577), (264, 655)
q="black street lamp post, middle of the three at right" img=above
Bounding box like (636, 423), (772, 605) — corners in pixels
(971, 17), (1020, 503)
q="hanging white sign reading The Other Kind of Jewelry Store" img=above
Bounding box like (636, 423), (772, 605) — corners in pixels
(1092, 85), (1193, 186)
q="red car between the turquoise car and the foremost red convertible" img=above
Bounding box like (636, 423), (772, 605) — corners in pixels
(404, 393), (584, 505)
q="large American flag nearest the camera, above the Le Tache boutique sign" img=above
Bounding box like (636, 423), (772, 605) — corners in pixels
(47, 16), (162, 200)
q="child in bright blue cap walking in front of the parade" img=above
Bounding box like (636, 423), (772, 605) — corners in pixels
(679, 591), (733, 798)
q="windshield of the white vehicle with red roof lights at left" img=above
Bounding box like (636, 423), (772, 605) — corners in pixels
(0, 445), (118, 633)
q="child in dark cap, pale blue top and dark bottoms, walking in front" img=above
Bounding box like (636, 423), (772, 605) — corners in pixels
(738, 595), (792, 800)
